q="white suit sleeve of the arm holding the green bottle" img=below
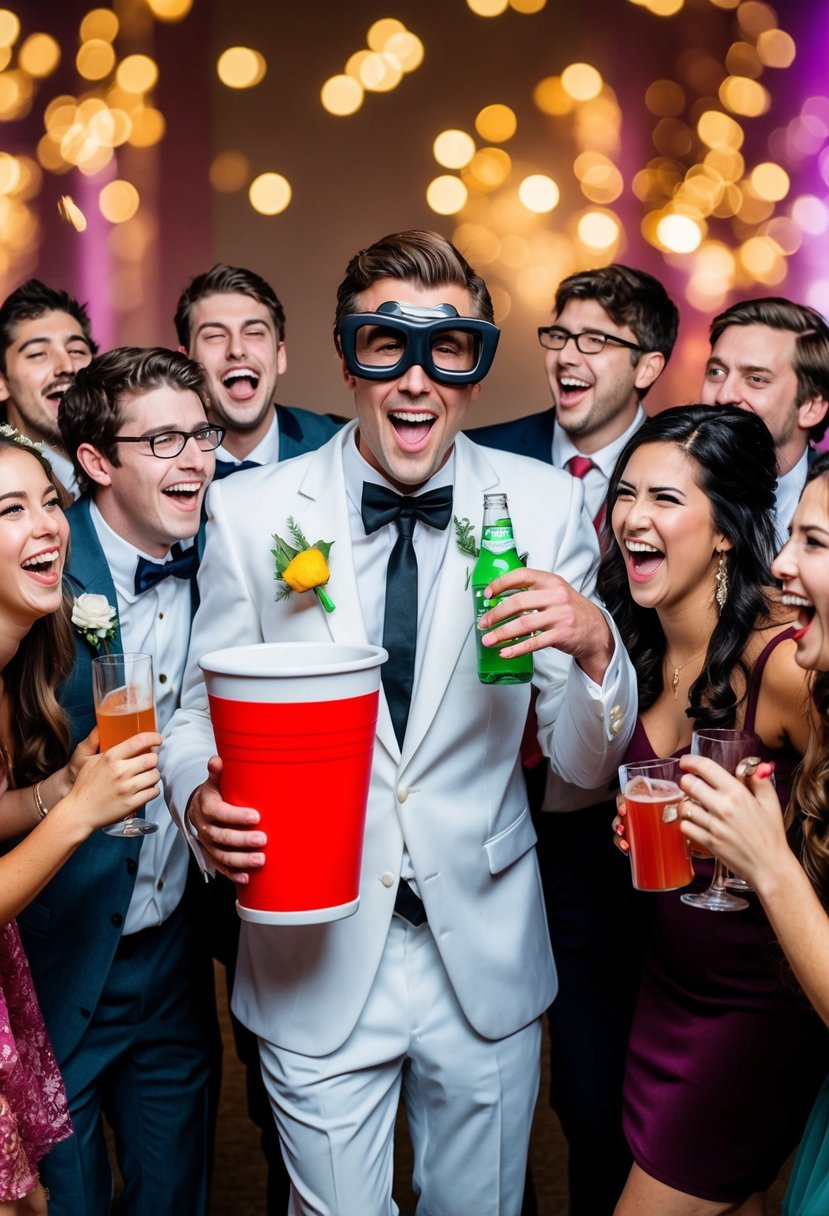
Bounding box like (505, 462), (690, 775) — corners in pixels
(530, 464), (637, 789)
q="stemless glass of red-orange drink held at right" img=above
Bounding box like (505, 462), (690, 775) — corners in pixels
(619, 758), (694, 891)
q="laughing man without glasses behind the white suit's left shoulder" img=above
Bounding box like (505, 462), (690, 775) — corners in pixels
(175, 264), (345, 479)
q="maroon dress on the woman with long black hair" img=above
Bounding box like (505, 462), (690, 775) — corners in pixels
(624, 630), (829, 1203)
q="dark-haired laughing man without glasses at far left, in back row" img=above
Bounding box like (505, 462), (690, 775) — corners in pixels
(0, 278), (97, 494)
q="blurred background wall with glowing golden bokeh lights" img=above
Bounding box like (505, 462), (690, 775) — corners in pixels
(0, 0), (829, 421)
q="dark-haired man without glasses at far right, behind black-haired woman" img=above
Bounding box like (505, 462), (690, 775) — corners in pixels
(699, 295), (829, 545)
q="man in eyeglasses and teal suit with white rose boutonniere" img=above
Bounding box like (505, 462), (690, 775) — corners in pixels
(21, 348), (222, 1216)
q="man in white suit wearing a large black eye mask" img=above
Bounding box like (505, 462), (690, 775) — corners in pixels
(162, 231), (636, 1216)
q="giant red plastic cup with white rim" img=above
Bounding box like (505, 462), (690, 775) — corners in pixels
(199, 642), (388, 924)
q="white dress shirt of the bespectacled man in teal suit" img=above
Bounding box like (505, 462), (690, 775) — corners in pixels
(90, 503), (191, 934)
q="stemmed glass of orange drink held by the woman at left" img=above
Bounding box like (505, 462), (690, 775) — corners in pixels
(92, 654), (158, 837)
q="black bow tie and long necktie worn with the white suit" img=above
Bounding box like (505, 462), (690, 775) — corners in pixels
(360, 482), (452, 748)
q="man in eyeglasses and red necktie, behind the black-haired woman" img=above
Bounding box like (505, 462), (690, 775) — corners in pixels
(469, 264), (678, 1216)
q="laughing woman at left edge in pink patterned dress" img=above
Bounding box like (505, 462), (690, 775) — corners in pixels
(0, 427), (160, 1216)
